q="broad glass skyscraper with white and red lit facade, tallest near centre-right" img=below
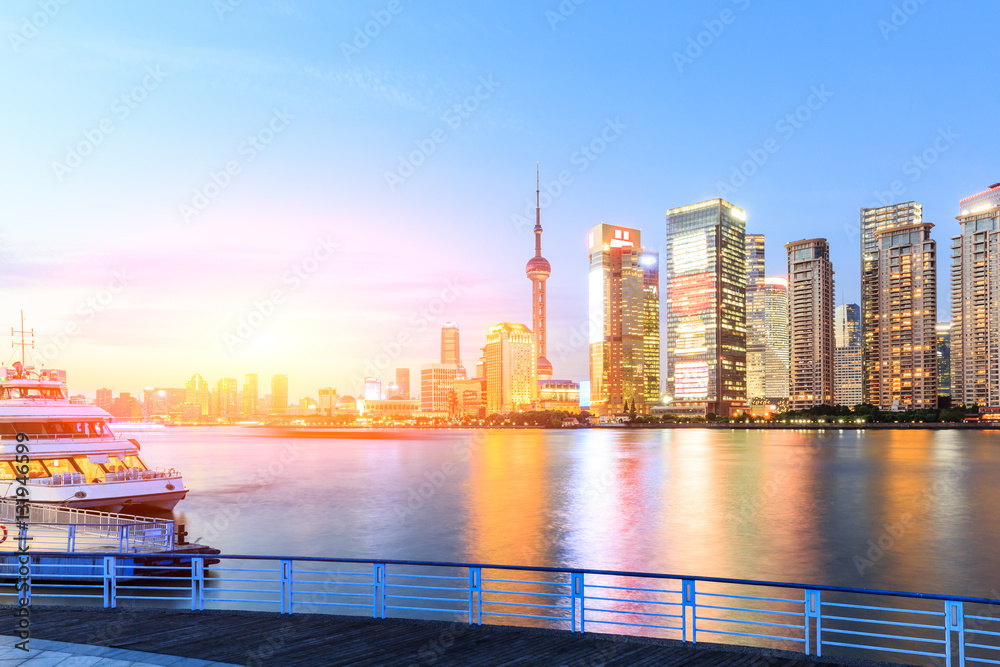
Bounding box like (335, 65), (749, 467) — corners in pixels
(665, 199), (747, 415)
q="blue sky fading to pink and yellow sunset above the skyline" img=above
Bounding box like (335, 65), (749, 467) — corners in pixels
(0, 0), (1000, 398)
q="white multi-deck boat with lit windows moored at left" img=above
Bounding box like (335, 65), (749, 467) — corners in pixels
(0, 363), (188, 512)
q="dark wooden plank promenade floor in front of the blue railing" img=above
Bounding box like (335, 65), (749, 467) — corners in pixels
(0, 606), (916, 667)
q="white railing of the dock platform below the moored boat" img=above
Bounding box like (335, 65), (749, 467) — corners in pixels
(0, 500), (175, 553)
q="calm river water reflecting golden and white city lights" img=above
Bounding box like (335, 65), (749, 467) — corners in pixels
(123, 427), (1000, 597)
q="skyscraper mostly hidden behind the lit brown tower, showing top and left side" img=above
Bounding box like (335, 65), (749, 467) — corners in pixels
(861, 201), (924, 403)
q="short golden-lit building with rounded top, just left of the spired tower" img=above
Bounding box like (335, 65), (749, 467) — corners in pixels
(484, 322), (538, 415)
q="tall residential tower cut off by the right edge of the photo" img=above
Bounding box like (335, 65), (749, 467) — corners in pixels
(951, 183), (1000, 407)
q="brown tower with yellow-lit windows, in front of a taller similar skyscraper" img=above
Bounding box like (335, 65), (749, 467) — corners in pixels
(865, 222), (937, 411)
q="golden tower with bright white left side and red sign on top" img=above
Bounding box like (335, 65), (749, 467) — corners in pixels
(588, 223), (658, 415)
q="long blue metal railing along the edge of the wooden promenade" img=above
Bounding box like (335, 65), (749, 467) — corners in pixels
(0, 553), (1000, 667)
